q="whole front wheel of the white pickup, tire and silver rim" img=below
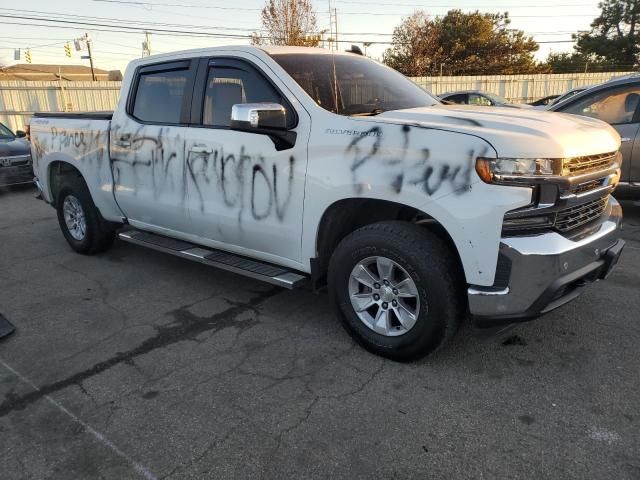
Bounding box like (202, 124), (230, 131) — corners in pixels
(329, 222), (464, 361)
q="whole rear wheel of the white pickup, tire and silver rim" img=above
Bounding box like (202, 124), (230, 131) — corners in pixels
(56, 177), (115, 254)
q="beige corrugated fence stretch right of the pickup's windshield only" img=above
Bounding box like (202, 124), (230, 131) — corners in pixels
(411, 72), (632, 103)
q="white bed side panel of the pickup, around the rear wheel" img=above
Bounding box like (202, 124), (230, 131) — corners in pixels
(31, 115), (123, 221)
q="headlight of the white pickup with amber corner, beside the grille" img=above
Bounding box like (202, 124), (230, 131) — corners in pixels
(476, 158), (562, 183)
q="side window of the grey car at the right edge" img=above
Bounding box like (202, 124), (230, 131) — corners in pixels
(561, 86), (640, 125)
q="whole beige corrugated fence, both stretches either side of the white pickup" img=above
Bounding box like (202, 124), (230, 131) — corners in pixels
(0, 72), (630, 130)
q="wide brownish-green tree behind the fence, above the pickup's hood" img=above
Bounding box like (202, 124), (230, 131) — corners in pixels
(383, 10), (548, 76)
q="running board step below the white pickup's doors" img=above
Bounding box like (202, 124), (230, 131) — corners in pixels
(118, 230), (307, 289)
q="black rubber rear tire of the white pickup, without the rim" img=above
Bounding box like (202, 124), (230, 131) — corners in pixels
(56, 177), (115, 255)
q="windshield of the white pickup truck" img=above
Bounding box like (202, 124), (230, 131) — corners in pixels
(271, 53), (439, 115)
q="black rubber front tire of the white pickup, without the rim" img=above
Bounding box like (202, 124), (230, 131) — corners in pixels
(328, 221), (466, 361)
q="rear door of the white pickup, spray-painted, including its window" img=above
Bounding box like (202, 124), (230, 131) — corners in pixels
(110, 59), (198, 234)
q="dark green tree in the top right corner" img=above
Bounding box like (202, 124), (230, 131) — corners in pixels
(574, 0), (640, 69)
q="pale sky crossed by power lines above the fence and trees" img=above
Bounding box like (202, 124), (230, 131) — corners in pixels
(0, 0), (599, 71)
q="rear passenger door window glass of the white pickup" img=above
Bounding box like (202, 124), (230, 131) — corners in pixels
(133, 68), (189, 124)
